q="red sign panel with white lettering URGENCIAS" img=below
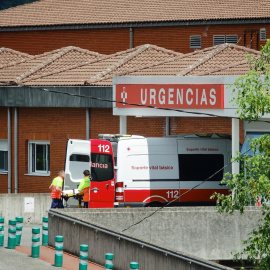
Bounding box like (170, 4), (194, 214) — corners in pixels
(115, 84), (224, 109)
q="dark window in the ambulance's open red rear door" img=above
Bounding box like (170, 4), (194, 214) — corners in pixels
(90, 153), (114, 181)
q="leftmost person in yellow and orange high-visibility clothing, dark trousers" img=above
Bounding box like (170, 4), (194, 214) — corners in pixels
(49, 170), (65, 208)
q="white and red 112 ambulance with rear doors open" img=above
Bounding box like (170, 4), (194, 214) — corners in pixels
(64, 134), (231, 208)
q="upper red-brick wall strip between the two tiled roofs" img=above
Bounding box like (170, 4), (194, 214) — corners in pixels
(0, 24), (270, 54)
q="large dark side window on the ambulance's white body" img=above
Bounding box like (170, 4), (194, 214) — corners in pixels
(179, 154), (224, 181)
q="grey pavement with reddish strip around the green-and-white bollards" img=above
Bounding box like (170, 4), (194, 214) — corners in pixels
(0, 225), (104, 270)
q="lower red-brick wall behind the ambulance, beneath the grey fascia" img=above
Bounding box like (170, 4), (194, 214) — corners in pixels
(0, 104), (244, 193)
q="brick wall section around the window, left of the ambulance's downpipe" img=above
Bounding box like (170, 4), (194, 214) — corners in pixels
(0, 108), (86, 193)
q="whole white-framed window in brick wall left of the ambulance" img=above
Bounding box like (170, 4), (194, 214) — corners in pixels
(29, 141), (50, 174)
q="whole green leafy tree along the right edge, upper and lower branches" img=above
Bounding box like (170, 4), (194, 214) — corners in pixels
(212, 40), (270, 270)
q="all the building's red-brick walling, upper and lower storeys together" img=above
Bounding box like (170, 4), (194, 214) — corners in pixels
(0, 21), (262, 193)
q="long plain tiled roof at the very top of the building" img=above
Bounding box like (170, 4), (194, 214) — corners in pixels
(0, 0), (270, 27)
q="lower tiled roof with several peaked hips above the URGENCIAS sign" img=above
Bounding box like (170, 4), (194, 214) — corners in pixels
(0, 44), (261, 86)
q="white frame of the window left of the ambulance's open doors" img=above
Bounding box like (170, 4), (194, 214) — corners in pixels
(28, 140), (51, 176)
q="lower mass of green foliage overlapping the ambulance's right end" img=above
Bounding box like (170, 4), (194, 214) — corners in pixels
(212, 135), (270, 270)
